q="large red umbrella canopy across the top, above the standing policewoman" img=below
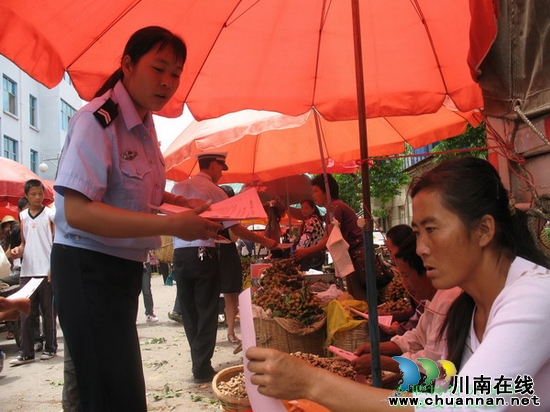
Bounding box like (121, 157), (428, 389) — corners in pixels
(0, 0), (494, 120)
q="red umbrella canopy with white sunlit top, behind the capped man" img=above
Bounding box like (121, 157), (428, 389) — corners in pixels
(164, 106), (481, 183)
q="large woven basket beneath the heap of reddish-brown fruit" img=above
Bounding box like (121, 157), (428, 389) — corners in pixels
(254, 318), (326, 356)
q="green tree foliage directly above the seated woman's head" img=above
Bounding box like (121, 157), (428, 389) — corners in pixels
(432, 123), (487, 163)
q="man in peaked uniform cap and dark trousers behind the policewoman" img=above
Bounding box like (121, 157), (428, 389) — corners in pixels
(172, 152), (277, 383)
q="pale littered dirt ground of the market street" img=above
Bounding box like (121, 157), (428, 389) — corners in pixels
(0, 276), (246, 412)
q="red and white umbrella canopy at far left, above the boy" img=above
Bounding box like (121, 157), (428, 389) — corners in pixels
(0, 157), (54, 209)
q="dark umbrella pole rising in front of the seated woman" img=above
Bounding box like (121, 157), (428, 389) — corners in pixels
(351, 0), (382, 388)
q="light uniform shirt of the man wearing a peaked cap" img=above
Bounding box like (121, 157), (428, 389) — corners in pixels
(172, 172), (239, 249)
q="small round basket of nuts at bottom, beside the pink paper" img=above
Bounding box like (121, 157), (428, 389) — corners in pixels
(212, 365), (252, 412)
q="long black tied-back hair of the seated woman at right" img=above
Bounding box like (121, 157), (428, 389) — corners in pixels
(409, 157), (548, 368)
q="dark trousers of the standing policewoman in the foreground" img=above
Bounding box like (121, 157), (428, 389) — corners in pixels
(51, 244), (147, 412)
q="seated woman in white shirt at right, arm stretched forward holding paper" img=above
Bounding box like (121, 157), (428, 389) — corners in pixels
(246, 157), (550, 412)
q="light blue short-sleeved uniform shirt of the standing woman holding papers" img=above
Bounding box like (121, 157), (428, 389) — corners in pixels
(54, 82), (166, 262)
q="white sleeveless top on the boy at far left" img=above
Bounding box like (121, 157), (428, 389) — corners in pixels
(19, 206), (54, 277)
